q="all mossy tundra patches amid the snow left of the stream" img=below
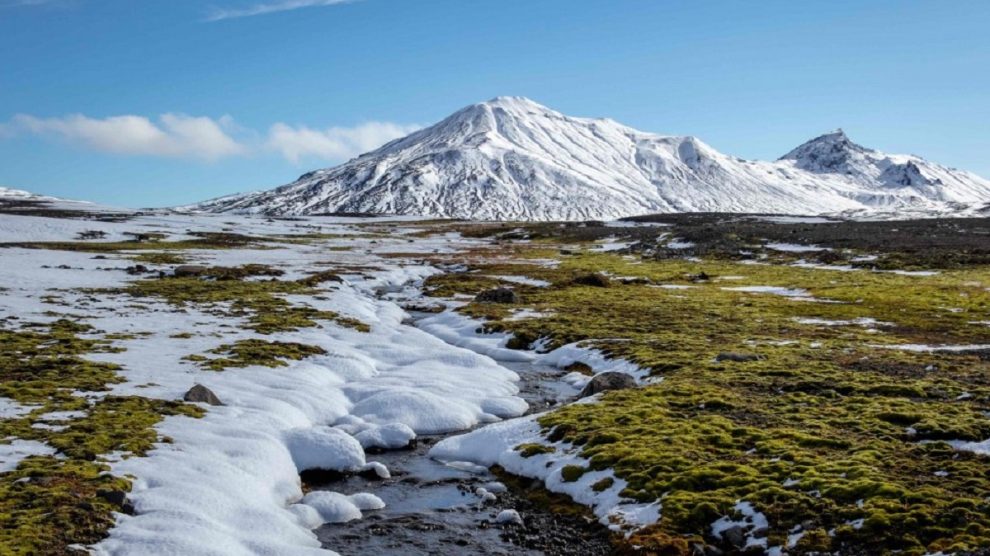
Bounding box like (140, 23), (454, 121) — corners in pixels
(0, 233), (367, 555)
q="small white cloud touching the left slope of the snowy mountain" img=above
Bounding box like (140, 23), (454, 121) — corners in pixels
(267, 122), (420, 163)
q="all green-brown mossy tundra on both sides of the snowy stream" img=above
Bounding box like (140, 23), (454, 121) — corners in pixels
(0, 216), (990, 555)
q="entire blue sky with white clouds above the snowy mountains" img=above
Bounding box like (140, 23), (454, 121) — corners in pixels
(0, 0), (990, 206)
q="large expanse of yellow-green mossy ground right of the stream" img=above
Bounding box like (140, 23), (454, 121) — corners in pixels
(426, 236), (990, 554)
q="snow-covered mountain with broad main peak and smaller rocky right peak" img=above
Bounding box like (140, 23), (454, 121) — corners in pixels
(183, 97), (990, 220)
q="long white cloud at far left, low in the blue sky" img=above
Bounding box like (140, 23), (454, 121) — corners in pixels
(9, 114), (247, 160)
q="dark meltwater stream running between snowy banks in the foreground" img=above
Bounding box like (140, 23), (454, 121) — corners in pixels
(308, 310), (611, 556)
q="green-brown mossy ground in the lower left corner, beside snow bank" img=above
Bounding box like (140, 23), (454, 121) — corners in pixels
(0, 320), (202, 555)
